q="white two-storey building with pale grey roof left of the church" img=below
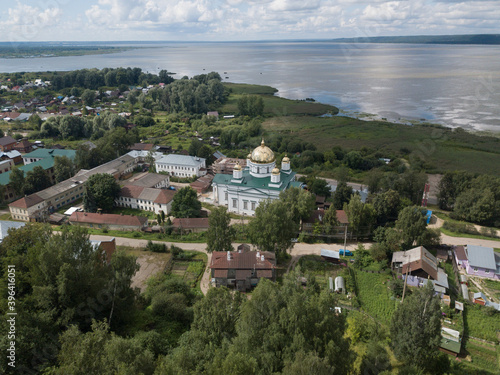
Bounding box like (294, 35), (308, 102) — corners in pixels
(156, 154), (207, 177)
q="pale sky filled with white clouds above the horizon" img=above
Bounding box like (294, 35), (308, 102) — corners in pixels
(0, 0), (500, 42)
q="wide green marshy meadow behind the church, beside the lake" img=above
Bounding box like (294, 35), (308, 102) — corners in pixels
(263, 113), (500, 175)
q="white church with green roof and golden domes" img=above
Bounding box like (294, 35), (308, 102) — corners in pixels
(212, 140), (302, 216)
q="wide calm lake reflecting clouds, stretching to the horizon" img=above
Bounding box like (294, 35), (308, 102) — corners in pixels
(0, 41), (500, 132)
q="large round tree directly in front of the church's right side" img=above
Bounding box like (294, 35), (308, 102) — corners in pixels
(248, 200), (299, 256)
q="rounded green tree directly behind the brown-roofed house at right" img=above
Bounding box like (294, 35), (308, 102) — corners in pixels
(396, 206), (427, 250)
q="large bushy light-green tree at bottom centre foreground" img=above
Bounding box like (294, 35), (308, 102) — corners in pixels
(229, 272), (353, 375)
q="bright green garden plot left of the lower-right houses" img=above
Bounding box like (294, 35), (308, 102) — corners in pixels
(356, 271), (398, 325)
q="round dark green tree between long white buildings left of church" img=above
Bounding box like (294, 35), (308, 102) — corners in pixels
(83, 173), (120, 212)
